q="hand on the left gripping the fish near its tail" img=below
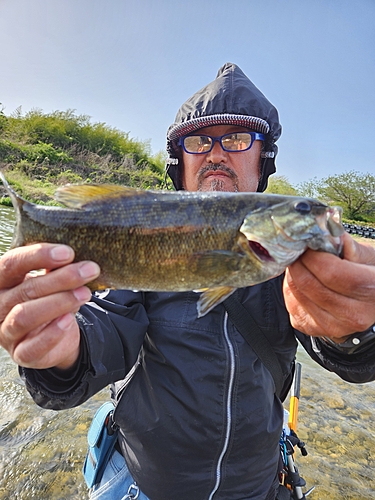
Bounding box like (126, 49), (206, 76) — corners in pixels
(0, 243), (100, 369)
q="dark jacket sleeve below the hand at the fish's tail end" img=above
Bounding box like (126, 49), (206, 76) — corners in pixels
(19, 290), (149, 410)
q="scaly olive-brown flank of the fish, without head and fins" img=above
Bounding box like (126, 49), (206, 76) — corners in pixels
(18, 192), (264, 291)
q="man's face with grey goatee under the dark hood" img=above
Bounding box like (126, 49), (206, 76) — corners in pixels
(182, 125), (262, 191)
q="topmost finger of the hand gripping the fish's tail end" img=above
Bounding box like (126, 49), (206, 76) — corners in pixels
(0, 243), (74, 289)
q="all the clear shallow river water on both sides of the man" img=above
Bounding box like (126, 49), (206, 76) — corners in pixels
(0, 205), (375, 500)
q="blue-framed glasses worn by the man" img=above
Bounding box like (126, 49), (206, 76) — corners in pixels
(178, 132), (264, 155)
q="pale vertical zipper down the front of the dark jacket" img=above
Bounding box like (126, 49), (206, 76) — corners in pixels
(208, 312), (235, 500)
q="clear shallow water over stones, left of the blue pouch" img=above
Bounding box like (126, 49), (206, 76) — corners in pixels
(0, 348), (107, 500)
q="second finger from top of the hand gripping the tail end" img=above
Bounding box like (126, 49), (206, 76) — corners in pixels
(0, 261), (100, 321)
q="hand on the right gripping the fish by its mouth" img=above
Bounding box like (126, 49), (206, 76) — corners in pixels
(284, 233), (375, 343)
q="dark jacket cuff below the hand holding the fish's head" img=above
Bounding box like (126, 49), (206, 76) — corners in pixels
(295, 330), (375, 384)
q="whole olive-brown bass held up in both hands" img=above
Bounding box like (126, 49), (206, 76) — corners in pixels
(0, 171), (345, 317)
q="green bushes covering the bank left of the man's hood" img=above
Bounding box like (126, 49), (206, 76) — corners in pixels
(0, 108), (166, 203)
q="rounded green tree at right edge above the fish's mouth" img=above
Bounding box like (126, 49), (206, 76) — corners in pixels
(318, 170), (375, 220)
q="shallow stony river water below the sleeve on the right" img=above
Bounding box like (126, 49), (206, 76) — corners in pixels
(288, 348), (375, 500)
